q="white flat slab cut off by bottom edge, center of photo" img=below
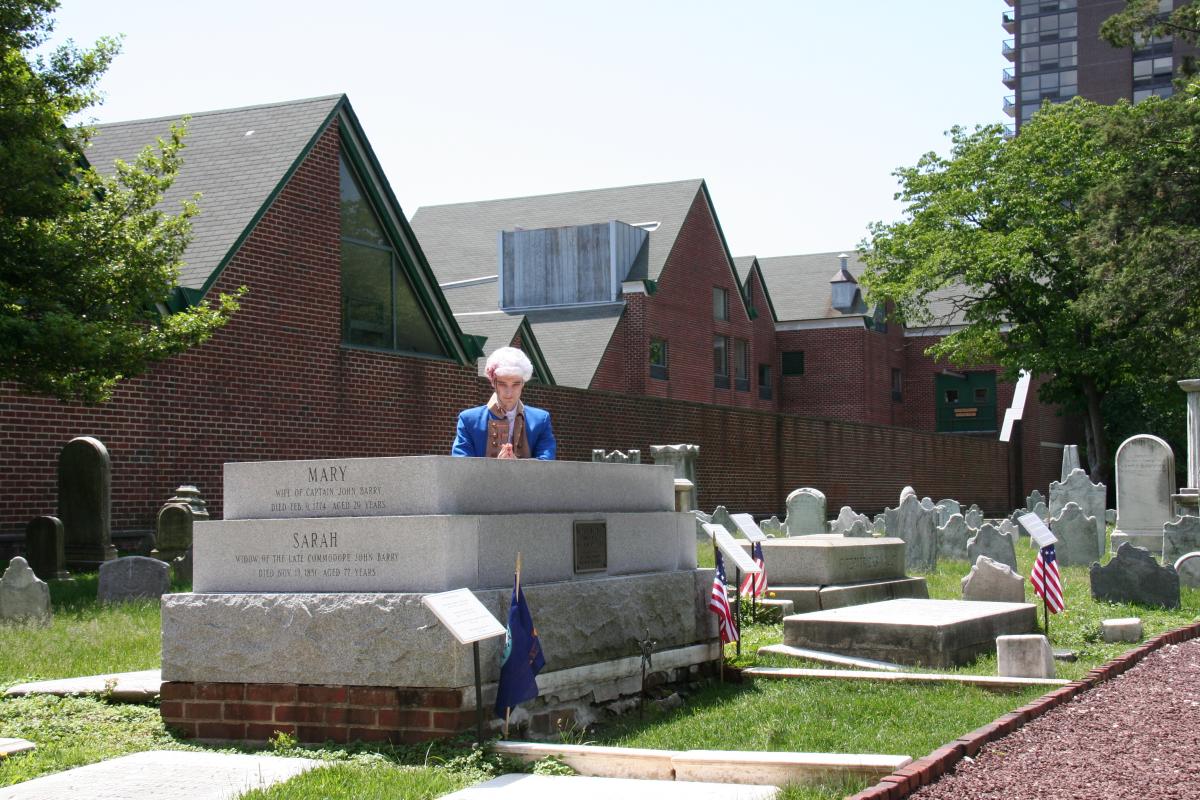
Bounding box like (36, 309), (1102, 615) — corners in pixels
(442, 774), (779, 800)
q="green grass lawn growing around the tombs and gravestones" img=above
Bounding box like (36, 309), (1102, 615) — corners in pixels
(0, 525), (1200, 800)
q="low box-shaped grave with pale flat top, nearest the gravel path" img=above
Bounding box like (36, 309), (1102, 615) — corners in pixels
(784, 599), (1037, 667)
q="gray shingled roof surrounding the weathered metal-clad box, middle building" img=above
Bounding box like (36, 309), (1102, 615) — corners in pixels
(412, 179), (703, 389)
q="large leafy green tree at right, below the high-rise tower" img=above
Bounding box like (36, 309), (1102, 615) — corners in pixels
(863, 86), (1200, 479)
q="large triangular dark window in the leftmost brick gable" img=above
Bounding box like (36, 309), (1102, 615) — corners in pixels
(340, 158), (446, 356)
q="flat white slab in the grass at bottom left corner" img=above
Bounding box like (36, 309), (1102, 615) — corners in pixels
(0, 751), (322, 800)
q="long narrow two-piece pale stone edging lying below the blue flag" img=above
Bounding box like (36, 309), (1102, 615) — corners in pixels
(492, 741), (912, 784)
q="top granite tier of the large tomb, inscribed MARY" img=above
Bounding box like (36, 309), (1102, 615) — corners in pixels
(223, 456), (674, 519)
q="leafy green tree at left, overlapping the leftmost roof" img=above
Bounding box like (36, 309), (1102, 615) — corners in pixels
(0, 0), (236, 403)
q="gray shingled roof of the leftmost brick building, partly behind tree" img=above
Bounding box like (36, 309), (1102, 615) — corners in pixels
(88, 95), (342, 289)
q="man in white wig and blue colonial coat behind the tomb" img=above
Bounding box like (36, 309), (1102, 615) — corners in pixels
(450, 347), (557, 461)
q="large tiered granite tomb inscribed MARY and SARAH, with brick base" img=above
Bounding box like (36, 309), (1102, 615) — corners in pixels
(162, 456), (720, 741)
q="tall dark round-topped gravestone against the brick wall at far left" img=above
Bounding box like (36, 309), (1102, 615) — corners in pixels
(59, 437), (116, 567)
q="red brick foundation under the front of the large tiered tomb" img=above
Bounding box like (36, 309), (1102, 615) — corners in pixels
(161, 681), (475, 744)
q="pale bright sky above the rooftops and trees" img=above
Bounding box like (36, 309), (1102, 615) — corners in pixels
(46, 0), (1010, 257)
